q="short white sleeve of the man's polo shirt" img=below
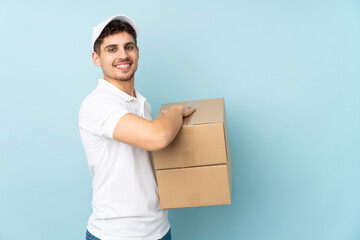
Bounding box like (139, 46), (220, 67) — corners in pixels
(79, 94), (130, 139)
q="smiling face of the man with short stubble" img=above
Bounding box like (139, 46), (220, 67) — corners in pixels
(92, 32), (139, 82)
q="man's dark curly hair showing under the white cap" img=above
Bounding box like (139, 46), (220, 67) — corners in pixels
(94, 20), (137, 55)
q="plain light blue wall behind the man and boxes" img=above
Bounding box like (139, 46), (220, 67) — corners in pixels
(0, 0), (360, 240)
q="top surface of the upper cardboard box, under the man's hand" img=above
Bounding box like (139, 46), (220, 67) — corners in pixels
(159, 98), (224, 126)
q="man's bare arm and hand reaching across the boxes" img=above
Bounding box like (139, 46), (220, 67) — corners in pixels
(113, 106), (195, 151)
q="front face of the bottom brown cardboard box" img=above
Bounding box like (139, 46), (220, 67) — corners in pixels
(156, 164), (231, 209)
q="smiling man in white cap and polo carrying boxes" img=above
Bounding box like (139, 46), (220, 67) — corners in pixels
(79, 15), (195, 240)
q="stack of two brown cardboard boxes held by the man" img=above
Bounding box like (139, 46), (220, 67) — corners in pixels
(154, 98), (231, 209)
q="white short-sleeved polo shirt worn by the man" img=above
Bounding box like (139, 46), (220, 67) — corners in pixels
(79, 79), (170, 240)
